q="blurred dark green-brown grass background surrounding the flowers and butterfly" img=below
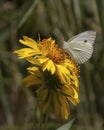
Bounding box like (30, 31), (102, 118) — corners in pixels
(0, 0), (104, 130)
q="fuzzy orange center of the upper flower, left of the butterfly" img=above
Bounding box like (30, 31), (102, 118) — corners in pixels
(40, 38), (65, 63)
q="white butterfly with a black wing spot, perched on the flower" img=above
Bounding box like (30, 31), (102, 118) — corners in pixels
(62, 31), (96, 64)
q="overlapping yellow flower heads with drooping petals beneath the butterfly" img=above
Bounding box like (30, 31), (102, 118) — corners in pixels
(14, 36), (79, 119)
